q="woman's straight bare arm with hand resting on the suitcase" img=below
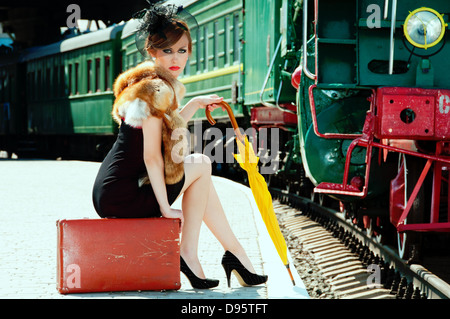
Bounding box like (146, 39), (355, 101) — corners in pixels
(142, 116), (183, 221)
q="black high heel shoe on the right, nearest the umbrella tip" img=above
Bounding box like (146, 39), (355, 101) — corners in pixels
(222, 250), (268, 287)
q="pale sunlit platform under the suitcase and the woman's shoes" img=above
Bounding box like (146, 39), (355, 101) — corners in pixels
(0, 160), (309, 299)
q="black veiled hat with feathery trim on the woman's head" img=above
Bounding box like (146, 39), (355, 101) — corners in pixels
(133, 0), (198, 59)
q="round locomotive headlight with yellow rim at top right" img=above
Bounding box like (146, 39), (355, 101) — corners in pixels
(403, 7), (447, 50)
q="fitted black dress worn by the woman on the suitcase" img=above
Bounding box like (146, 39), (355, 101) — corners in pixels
(92, 121), (184, 218)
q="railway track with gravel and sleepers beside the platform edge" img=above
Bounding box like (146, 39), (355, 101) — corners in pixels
(270, 188), (450, 299)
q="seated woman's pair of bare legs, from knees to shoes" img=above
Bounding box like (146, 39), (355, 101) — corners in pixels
(180, 154), (255, 278)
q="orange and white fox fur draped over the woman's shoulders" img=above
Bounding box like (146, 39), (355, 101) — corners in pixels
(112, 62), (187, 184)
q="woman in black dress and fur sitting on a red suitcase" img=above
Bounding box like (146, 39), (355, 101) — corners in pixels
(93, 6), (267, 288)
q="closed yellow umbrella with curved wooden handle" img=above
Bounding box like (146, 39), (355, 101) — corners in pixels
(205, 102), (295, 286)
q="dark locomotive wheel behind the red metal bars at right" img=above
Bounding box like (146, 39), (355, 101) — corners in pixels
(397, 154), (425, 259)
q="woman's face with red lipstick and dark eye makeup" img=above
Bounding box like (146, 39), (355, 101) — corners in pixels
(151, 34), (189, 78)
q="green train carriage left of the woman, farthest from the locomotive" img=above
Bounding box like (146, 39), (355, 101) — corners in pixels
(14, 25), (123, 159)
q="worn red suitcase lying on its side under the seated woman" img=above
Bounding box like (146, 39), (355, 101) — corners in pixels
(57, 218), (181, 294)
